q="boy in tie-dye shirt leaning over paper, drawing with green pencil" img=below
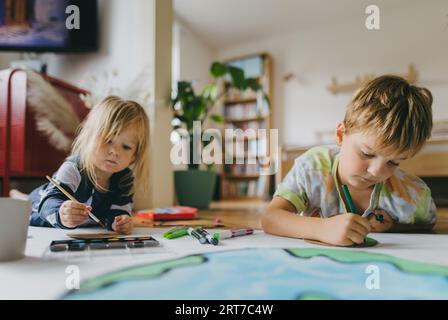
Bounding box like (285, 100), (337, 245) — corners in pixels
(262, 75), (436, 246)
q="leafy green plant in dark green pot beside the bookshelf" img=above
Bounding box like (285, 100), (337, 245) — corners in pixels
(171, 62), (267, 209)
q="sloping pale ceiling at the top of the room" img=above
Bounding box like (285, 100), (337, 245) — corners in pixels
(174, 0), (419, 50)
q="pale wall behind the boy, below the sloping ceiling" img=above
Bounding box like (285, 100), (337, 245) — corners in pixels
(218, 0), (448, 145)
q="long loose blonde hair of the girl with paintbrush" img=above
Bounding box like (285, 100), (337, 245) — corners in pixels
(72, 96), (149, 193)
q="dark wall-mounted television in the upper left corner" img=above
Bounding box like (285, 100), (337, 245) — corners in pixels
(0, 0), (98, 52)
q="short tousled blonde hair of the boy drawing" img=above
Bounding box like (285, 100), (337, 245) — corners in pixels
(344, 75), (433, 156)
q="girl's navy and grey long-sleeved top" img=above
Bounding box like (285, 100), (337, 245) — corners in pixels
(29, 156), (133, 230)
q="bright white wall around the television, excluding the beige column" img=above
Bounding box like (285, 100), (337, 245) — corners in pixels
(0, 0), (154, 94)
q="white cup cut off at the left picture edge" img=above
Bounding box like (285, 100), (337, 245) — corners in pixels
(0, 198), (31, 261)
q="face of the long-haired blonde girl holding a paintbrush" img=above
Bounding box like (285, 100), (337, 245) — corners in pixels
(95, 127), (138, 176)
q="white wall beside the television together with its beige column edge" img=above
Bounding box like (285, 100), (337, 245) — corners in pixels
(0, 0), (173, 208)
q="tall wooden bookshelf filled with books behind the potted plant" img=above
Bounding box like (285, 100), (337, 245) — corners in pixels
(220, 53), (273, 200)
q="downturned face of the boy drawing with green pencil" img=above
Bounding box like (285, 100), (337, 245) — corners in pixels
(337, 124), (408, 190)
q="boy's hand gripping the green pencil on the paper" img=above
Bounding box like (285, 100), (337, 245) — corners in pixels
(319, 213), (371, 246)
